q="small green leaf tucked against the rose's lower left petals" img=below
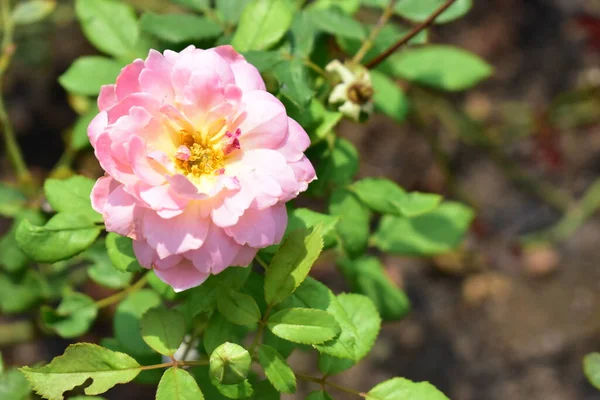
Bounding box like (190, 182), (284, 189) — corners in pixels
(82, 240), (133, 289)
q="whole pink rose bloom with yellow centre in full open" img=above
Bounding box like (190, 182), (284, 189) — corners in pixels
(88, 46), (316, 291)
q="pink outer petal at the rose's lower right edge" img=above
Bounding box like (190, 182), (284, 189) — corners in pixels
(225, 204), (287, 248)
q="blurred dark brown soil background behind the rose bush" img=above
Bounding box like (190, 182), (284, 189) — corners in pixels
(0, 0), (600, 400)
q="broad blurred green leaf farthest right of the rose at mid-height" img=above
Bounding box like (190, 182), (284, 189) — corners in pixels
(372, 202), (474, 256)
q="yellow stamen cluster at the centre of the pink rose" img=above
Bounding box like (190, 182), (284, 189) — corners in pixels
(175, 129), (241, 178)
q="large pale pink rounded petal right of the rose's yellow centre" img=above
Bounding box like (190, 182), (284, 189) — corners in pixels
(239, 90), (287, 150)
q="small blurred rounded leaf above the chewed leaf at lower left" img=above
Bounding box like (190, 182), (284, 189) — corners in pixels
(41, 293), (98, 338)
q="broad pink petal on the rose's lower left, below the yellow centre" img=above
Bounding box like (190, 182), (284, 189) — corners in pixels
(143, 208), (210, 258)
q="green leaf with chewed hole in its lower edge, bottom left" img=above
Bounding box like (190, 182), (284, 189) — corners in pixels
(20, 343), (141, 400)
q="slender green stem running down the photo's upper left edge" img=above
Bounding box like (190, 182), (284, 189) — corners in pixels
(0, 0), (33, 191)
